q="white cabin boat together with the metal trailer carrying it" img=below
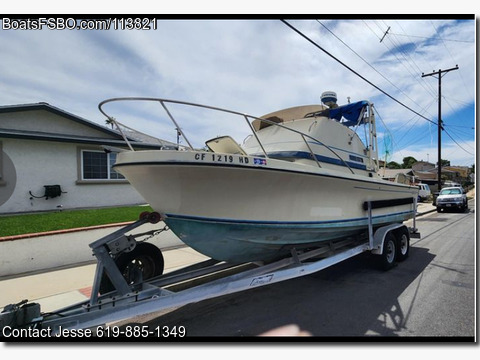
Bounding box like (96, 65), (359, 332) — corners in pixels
(0, 94), (420, 334)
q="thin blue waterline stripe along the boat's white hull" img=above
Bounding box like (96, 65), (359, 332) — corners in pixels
(165, 210), (414, 226)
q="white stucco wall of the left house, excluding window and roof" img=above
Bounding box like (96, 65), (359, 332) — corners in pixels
(0, 138), (145, 213)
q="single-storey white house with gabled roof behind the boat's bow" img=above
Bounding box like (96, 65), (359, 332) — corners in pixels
(0, 103), (158, 214)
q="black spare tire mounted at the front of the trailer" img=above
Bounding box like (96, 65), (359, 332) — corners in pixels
(99, 243), (165, 294)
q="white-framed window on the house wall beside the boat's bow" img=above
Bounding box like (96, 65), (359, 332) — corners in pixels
(82, 150), (125, 180)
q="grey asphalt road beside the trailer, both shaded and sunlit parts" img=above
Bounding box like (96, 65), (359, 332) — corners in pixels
(122, 201), (475, 341)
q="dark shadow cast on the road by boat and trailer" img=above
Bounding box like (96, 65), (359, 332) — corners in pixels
(134, 247), (434, 341)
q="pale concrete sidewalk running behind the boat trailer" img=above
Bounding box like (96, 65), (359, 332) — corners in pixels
(0, 203), (436, 312)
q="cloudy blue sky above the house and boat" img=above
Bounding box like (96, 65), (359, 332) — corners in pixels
(0, 15), (476, 166)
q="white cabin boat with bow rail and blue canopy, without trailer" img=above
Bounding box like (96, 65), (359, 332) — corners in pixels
(99, 92), (418, 263)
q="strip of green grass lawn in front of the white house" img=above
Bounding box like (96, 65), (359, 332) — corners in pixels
(0, 206), (153, 237)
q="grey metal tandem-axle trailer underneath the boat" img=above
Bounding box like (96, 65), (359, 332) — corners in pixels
(0, 201), (420, 337)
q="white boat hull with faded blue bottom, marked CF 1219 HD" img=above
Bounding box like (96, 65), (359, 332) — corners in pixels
(115, 151), (418, 262)
